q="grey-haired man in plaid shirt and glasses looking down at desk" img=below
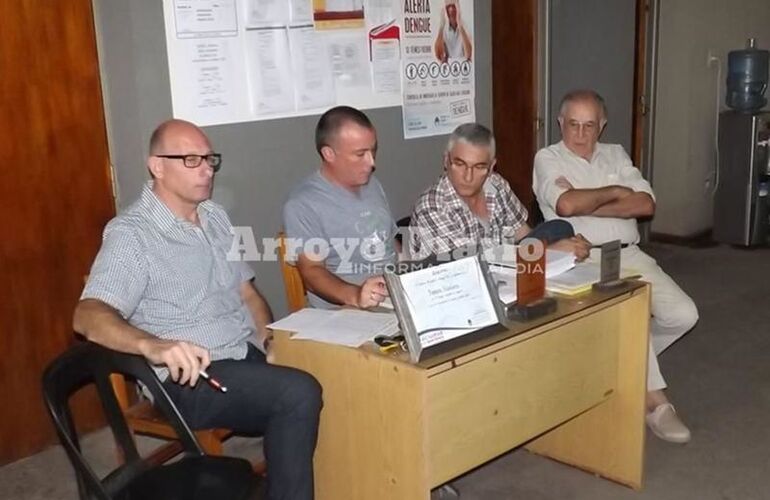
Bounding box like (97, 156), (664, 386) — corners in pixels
(409, 123), (591, 260)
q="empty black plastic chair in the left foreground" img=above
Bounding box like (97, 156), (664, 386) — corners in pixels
(43, 342), (261, 500)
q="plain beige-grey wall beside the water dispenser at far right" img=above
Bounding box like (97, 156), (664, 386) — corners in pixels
(652, 0), (770, 236)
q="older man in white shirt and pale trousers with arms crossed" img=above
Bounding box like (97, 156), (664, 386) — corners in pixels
(533, 90), (698, 443)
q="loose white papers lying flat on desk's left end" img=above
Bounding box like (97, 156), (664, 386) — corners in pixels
(267, 307), (398, 347)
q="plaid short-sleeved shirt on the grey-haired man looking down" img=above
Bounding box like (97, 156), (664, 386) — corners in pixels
(409, 172), (527, 259)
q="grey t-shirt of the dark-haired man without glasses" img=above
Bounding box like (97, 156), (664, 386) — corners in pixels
(283, 170), (396, 308)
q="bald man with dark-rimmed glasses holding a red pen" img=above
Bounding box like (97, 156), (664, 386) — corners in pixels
(73, 120), (321, 500)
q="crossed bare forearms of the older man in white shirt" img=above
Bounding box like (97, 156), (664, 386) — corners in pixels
(555, 176), (655, 219)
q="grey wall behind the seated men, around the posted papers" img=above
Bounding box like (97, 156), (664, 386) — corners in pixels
(94, 0), (492, 317)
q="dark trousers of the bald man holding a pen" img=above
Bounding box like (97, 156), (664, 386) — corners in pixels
(163, 344), (321, 500)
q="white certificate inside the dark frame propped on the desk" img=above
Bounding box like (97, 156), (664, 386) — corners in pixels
(399, 257), (498, 348)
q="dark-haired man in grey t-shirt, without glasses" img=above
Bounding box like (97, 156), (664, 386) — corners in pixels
(283, 106), (396, 309)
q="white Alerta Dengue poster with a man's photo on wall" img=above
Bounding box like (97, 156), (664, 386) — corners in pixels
(401, 0), (476, 139)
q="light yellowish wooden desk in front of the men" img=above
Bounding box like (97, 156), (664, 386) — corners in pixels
(273, 283), (650, 500)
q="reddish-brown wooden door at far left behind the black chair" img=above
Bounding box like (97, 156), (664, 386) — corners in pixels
(0, 0), (114, 464)
